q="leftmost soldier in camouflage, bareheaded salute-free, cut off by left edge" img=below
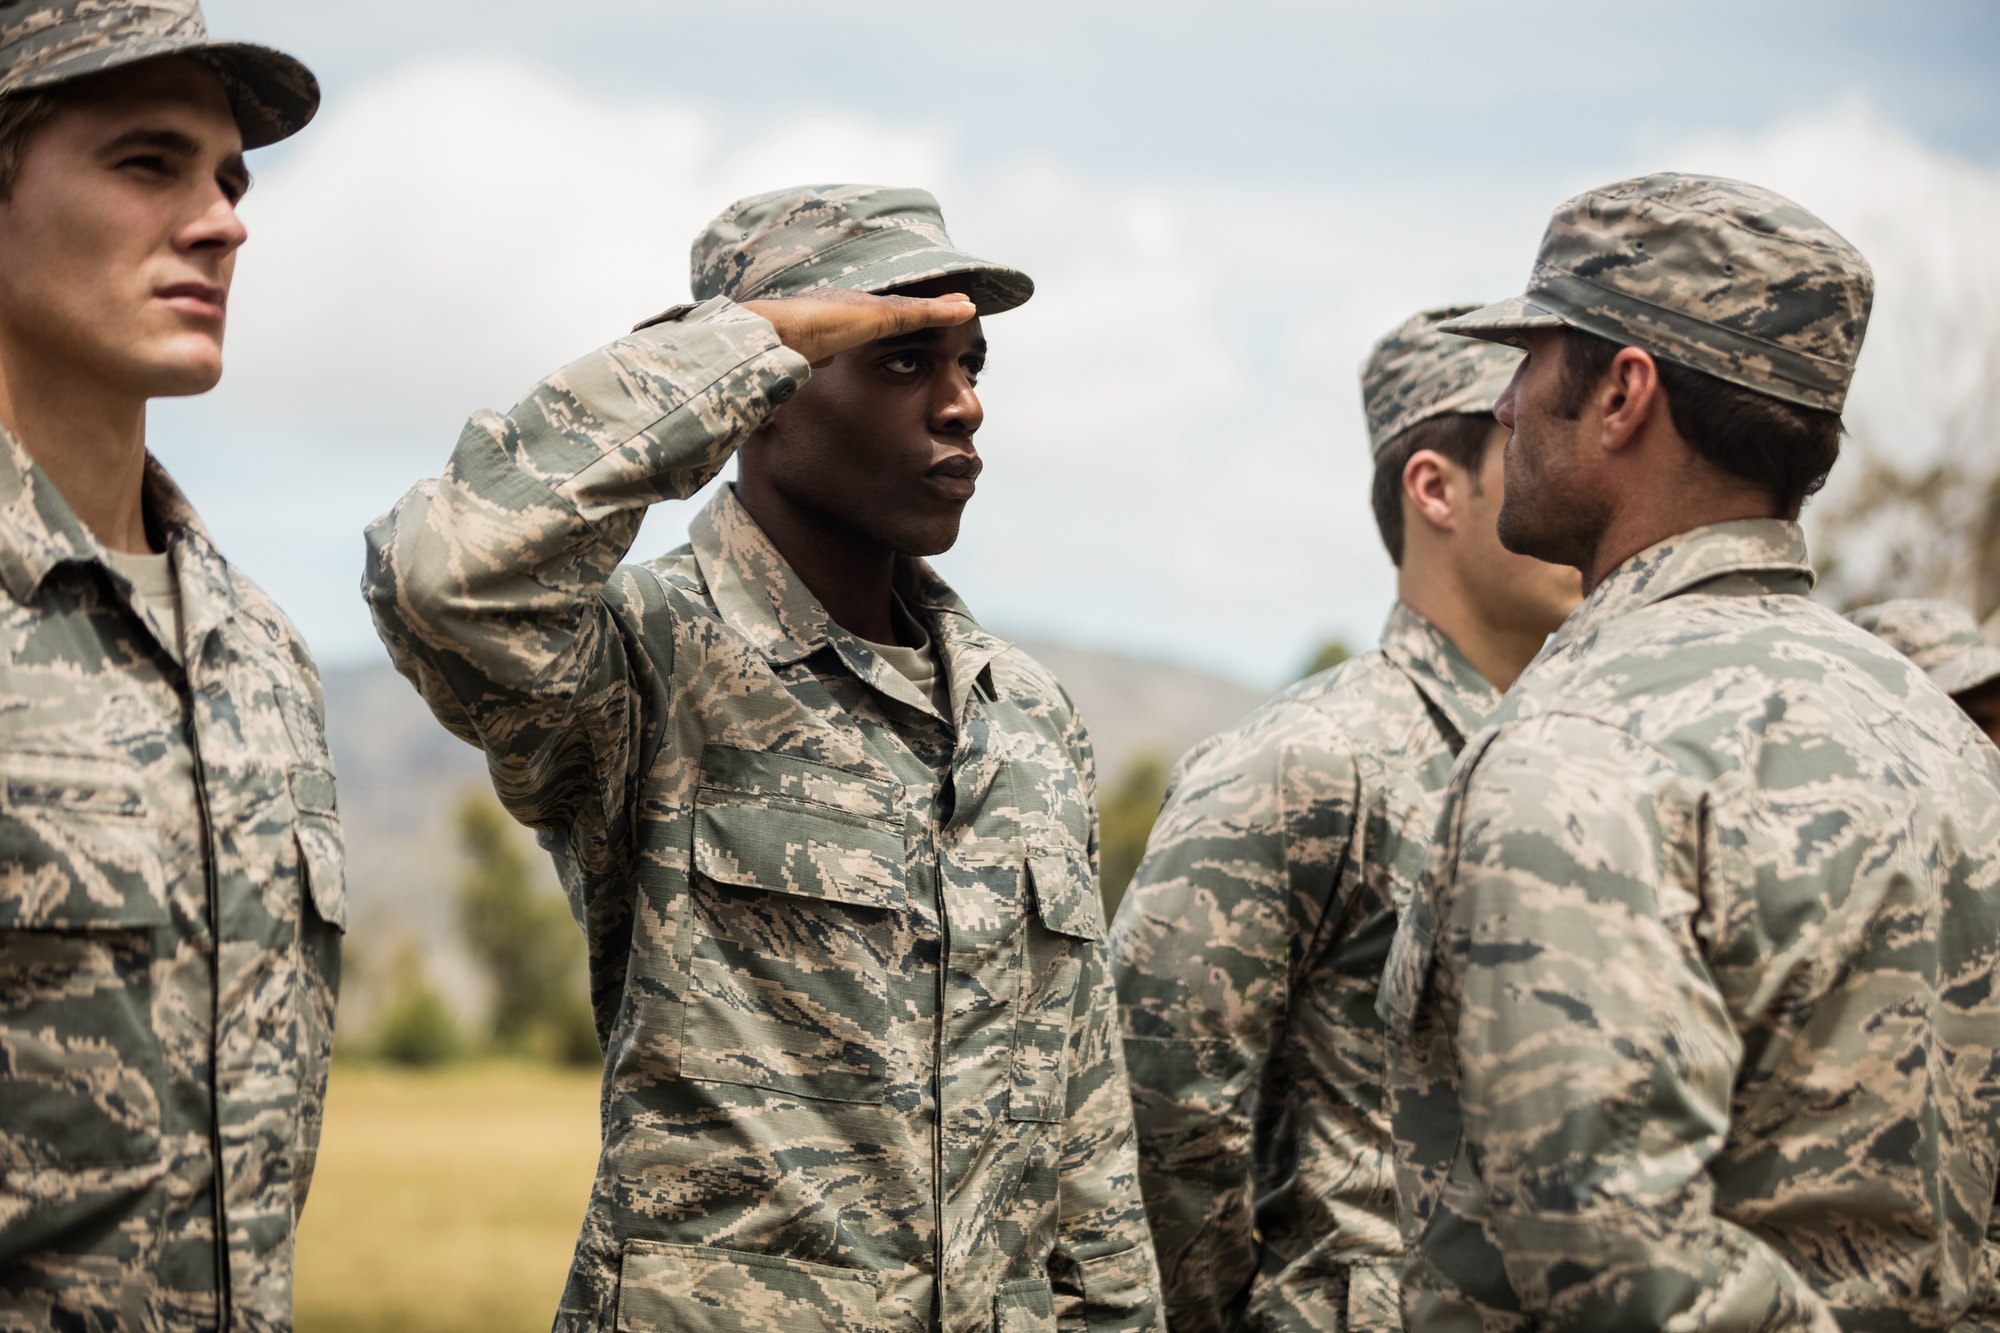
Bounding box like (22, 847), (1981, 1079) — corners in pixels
(0, 0), (346, 1333)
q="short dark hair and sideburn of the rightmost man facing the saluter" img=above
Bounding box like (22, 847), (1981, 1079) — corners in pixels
(1556, 328), (1842, 518)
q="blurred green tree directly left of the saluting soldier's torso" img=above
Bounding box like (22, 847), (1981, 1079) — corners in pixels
(458, 793), (598, 1065)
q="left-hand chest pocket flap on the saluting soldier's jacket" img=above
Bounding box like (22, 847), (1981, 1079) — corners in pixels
(694, 793), (904, 907)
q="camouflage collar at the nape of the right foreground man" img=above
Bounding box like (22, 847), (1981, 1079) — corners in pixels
(1542, 518), (1816, 656)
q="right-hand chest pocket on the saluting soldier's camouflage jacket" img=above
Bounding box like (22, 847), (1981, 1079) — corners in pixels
(1008, 851), (1104, 1121)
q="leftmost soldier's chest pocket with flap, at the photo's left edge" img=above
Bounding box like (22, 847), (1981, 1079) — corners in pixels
(0, 755), (170, 1168)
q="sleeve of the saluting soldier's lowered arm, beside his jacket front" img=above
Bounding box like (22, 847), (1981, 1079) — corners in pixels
(1050, 701), (1166, 1333)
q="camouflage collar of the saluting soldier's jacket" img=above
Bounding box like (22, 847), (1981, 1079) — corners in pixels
(688, 486), (1012, 717)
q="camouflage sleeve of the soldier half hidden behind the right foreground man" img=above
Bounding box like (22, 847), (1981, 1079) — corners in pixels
(1112, 715), (1354, 1333)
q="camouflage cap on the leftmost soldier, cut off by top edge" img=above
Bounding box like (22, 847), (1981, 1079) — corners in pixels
(0, 0), (320, 148)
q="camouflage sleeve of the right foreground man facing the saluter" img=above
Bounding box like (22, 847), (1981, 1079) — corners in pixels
(1432, 715), (1834, 1333)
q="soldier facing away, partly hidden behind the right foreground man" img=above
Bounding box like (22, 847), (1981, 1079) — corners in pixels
(1112, 306), (1580, 1333)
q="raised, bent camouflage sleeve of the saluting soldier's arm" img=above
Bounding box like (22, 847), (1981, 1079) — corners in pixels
(362, 300), (810, 856)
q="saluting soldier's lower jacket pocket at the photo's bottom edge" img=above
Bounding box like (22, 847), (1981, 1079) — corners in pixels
(618, 1241), (876, 1333)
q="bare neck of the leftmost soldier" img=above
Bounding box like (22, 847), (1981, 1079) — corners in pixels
(0, 346), (152, 554)
